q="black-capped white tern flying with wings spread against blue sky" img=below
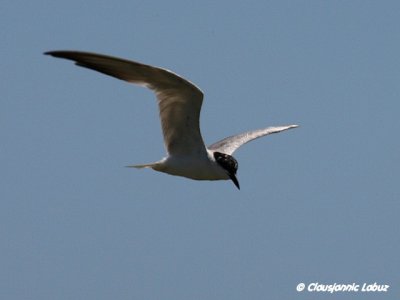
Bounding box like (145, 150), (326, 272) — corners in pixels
(44, 51), (298, 189)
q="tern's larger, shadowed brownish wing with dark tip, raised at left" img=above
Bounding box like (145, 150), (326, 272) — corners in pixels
(45, 51), (206, 155)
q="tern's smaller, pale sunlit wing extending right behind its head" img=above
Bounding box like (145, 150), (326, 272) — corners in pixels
(208, 125), (298, 155)
